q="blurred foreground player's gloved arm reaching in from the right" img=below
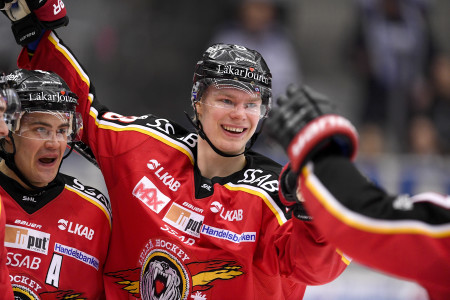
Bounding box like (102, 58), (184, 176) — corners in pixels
(270, 86), (450, 300)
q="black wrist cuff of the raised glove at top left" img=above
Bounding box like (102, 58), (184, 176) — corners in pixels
(11, 13), (45, 46)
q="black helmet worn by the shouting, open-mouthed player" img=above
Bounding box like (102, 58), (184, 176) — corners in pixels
(4, 69), (82, 141)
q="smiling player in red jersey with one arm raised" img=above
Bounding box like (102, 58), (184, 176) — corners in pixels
(0, 2), (348, 299)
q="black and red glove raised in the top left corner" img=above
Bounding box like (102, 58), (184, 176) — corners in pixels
(0, 0), (69, 46)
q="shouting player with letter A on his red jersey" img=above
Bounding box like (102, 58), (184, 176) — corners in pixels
(0, 69), (111, 299)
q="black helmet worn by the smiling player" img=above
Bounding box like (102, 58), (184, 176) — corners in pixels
(191, 44), (272, 118)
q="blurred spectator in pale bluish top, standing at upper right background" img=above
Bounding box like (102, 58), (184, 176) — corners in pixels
(349, 0), (436, 151)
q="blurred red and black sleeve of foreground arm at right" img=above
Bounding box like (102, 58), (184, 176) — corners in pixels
(299, 156), (450, 289)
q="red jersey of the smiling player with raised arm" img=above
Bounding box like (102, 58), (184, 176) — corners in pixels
(19, 33), (348, 300)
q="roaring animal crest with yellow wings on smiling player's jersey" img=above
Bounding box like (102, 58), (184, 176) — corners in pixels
(106, 239), (244, 300)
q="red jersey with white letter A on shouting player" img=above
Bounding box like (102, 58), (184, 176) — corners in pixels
(0, 173), (111, 300)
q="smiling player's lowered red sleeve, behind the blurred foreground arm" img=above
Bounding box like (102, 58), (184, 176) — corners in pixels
(256, 173), (350, 285)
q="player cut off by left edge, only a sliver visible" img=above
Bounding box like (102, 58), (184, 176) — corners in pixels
(0, 76), (20, 300)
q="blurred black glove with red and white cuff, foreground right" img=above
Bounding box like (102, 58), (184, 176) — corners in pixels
(266, 85), (358, 173)
